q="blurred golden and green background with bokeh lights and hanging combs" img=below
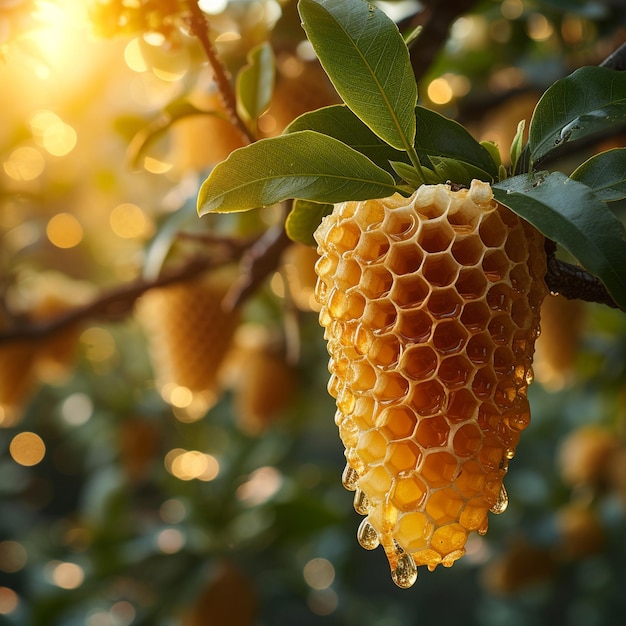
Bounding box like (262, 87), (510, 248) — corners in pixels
(0, 0), (626, 626)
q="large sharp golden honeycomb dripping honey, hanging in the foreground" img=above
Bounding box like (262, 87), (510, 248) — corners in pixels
(315, 181), (546, 587)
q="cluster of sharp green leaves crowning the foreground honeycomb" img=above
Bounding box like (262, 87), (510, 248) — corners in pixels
(198, 0), (626, 308)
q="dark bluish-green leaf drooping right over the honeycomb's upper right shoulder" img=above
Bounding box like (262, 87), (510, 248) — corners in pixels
(493, 172), (626, 309)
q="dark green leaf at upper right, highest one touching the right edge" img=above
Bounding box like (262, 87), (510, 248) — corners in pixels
(528, 67), (626, 165)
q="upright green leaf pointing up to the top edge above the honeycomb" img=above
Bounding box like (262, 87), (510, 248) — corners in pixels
(298, 0), (417, 151)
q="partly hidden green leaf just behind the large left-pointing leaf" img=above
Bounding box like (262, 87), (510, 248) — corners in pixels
(284, 104), (408, 173)
